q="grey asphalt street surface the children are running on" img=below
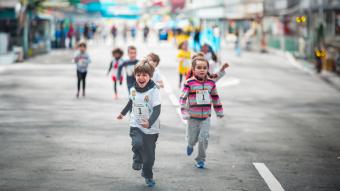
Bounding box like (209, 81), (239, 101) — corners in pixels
(0, 35), (340, 191)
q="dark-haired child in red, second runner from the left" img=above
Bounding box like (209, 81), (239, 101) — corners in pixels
(107, 48), (124, 99)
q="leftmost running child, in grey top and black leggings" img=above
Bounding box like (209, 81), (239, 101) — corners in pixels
(73, 42), (91, 98)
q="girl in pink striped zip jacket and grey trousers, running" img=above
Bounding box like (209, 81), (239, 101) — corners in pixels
(180, 57), (223, 168)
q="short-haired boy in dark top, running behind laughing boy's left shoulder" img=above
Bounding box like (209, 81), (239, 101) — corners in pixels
(118, 46), (138, 93)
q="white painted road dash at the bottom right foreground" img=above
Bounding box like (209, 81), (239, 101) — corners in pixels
(253, 163), (284, 191)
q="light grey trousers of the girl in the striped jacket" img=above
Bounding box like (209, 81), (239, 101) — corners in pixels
(187, 117), (210, 162)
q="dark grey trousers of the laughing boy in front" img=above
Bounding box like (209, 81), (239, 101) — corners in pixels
(130, 127), (158, 178)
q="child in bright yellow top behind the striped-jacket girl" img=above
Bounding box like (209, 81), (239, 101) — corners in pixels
(177, 41), (191, 88)
